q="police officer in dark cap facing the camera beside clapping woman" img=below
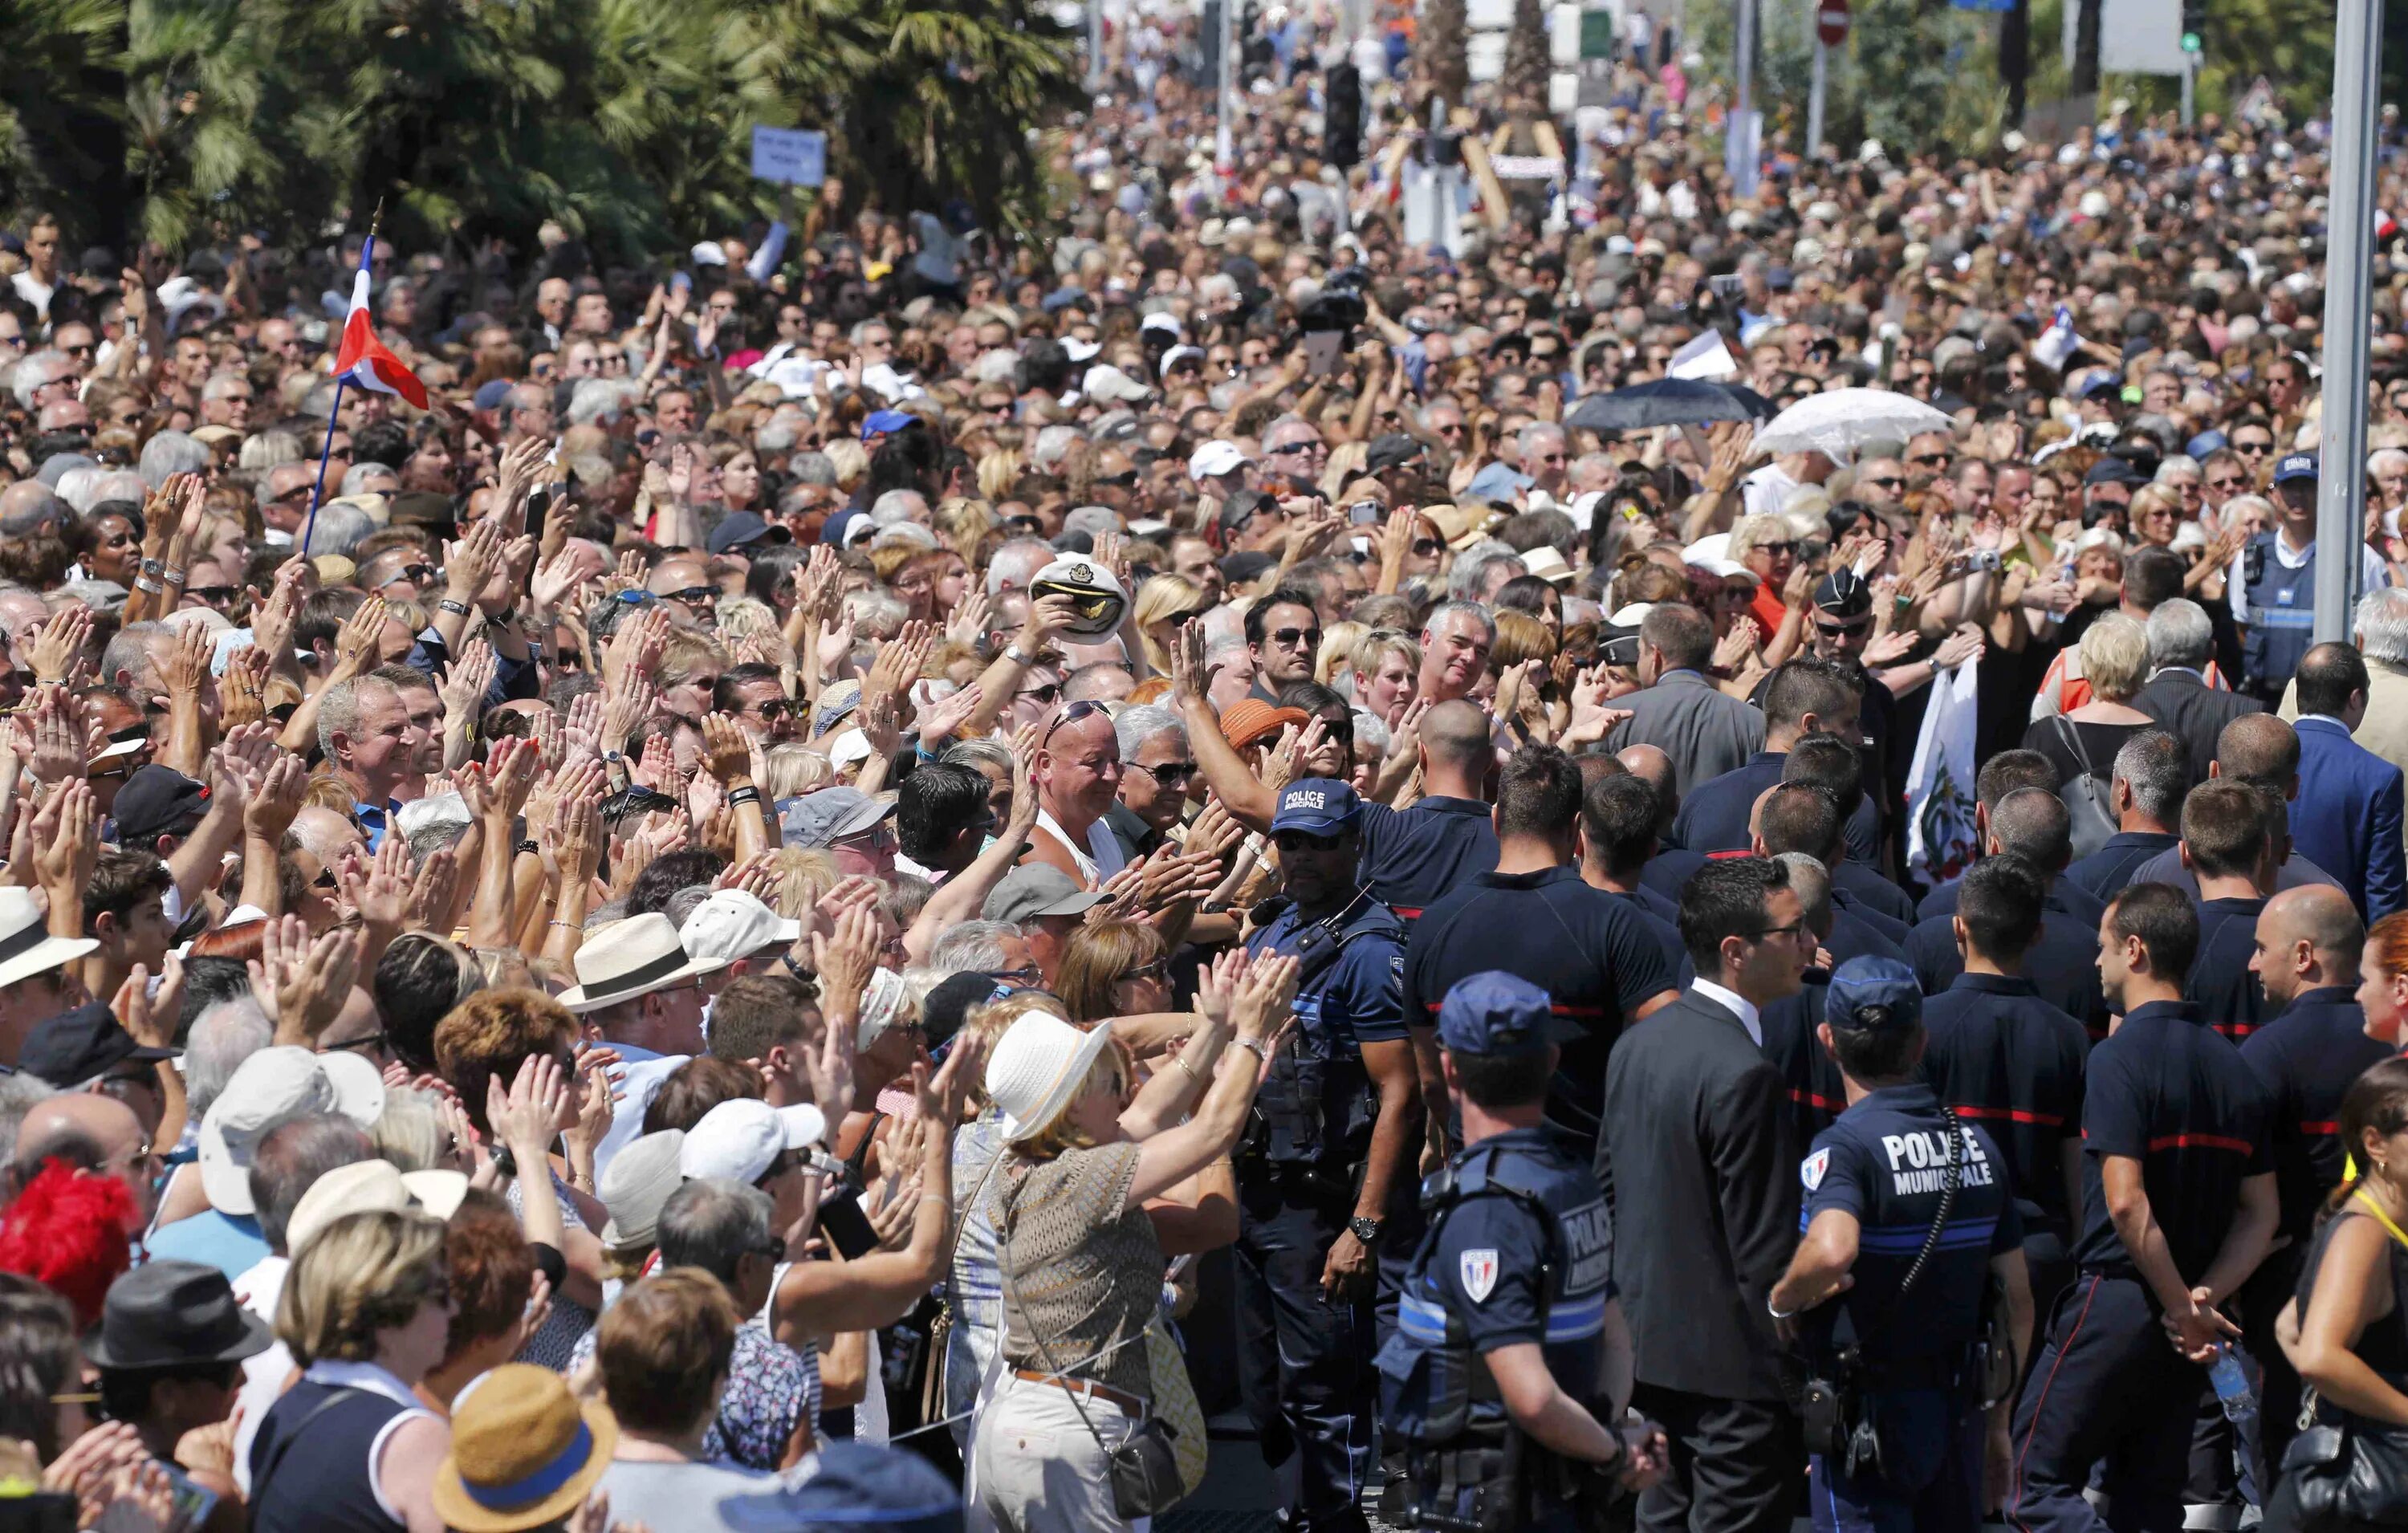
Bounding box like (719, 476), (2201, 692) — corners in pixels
(1238, 777), (1421, 1528)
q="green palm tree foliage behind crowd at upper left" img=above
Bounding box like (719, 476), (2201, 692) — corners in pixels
(16, 0), (1081, 258)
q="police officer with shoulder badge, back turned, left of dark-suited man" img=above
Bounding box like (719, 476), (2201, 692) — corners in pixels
(1380, 972), (1666, 1533)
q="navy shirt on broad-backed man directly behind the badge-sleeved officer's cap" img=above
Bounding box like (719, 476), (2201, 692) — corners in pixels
(1404, 866), (1676, 1155)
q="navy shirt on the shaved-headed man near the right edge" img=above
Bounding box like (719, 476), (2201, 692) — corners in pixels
(2242, 984), (2391, 1242)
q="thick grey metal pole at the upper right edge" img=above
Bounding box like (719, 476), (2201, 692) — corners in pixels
(2314, 0), (2384, 643)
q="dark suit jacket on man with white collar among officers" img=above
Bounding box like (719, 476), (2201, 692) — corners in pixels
(1597, 991), (1804, 1401)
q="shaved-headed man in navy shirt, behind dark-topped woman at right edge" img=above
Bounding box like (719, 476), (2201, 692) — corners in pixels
(2239, 888), (2394, 1463)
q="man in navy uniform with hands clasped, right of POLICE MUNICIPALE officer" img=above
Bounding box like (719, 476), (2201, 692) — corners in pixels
(2006, 883), (2276, 1533)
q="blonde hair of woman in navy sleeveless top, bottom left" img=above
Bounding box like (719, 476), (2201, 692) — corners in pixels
(277, 1208), (448, 1367)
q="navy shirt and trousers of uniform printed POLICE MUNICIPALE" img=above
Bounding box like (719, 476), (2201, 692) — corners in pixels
(1799, 1080), (2023, 1533)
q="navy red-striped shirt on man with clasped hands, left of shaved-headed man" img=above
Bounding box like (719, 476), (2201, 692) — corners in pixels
(2073, 1001), (2273, 1283)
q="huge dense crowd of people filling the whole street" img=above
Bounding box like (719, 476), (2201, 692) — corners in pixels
(0, 7), (2408, 1533)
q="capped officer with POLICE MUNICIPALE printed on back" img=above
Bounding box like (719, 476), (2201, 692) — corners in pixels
(1770, 958), (2032, 1533)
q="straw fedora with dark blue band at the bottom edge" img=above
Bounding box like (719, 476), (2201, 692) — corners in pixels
(433, 1362), (619, 1533)
